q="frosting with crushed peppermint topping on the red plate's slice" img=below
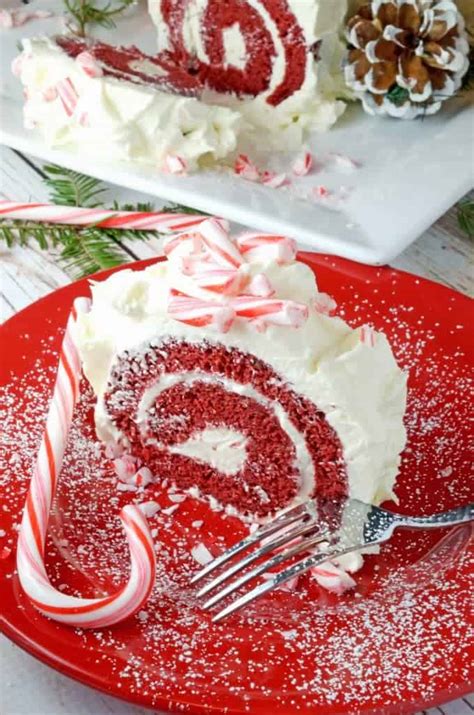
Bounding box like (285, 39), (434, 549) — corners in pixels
(74, 229), (406, 510)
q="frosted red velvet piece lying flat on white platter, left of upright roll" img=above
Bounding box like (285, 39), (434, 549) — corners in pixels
(13, 37), (241, 173)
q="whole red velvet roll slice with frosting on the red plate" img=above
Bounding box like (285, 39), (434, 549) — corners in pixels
(78, 219), (406, 521)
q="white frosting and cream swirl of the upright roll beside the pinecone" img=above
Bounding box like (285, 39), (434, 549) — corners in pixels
(149, 0), (347, 149)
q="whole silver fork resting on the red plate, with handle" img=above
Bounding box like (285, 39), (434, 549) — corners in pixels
(191, 499), (474, 622)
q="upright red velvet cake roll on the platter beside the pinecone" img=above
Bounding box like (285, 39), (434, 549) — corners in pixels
(149, 0), (347, 140)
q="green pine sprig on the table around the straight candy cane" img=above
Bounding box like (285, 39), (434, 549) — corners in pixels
(0, 165), (206, 278)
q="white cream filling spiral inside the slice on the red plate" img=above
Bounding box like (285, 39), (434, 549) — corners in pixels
(136, 371), (317, 498)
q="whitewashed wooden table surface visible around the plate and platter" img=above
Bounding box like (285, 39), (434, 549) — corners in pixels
(0, 147), (474, 715)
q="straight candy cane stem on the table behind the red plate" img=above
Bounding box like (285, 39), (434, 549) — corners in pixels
(0, 201), (208, 233)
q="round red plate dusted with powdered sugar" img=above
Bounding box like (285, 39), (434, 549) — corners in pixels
(0, 255), (473, 715)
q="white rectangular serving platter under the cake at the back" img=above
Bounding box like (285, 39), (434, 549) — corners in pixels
(0, 0), (474, 264)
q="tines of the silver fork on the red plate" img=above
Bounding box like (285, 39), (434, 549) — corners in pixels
(191, 502), (344, 621)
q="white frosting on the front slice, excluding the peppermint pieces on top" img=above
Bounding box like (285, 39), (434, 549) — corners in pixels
(78, 252), (406, 510)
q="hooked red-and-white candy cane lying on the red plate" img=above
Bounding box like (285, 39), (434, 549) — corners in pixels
(17, 298), (155, 628)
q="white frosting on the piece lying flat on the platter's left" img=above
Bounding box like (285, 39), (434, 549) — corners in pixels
(20, 38), (240, 169)
